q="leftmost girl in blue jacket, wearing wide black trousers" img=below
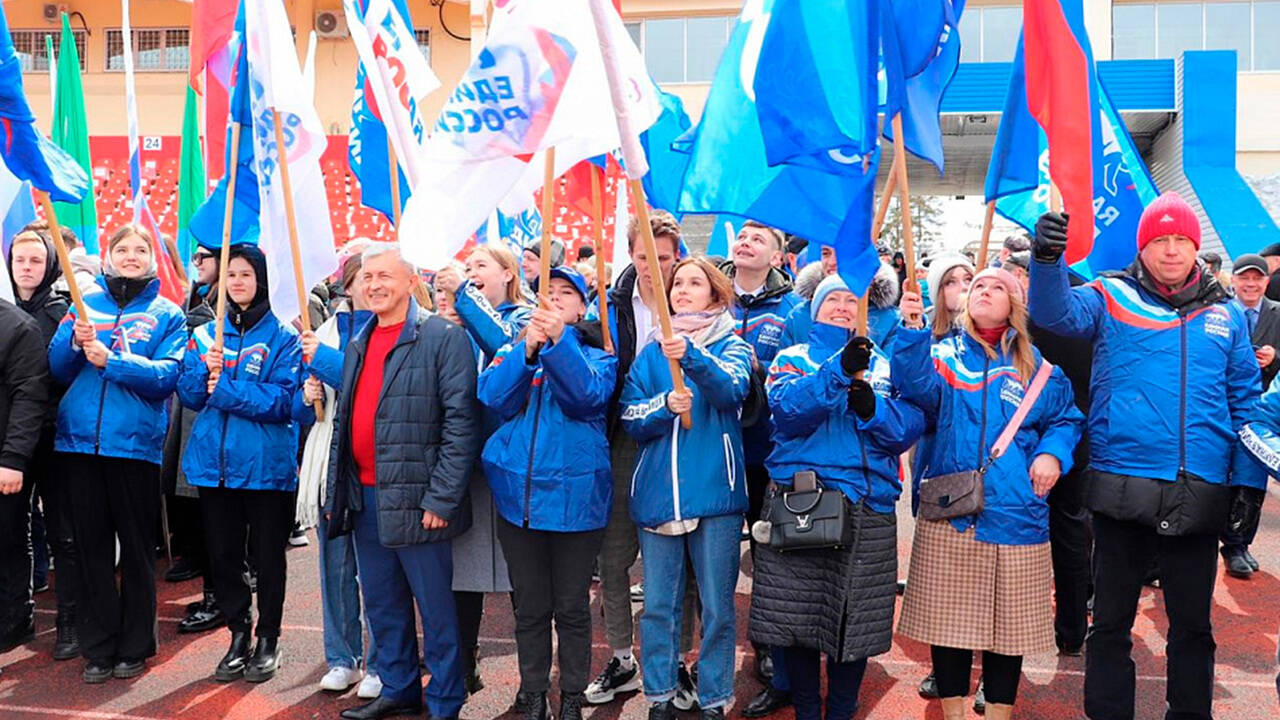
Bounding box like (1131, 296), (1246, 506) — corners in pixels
(49, 224), (187, 683)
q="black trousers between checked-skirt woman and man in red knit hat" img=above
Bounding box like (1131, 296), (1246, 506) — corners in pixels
(1048, 468), (1093, 650)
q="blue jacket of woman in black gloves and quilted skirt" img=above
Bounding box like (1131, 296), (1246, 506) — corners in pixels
(765, 323), (924, 512)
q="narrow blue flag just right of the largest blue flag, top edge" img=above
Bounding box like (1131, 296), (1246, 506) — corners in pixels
(882, 0), (964, 173)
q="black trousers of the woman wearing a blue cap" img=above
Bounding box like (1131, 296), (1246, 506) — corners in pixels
(498, 519), (604, 693)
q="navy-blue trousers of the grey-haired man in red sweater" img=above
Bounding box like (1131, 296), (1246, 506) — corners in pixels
(355, 487), (463, 717)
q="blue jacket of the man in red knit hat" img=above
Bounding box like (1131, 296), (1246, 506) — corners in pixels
(1030, 261), (1266, 487)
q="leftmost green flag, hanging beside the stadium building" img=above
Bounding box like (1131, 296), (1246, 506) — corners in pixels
(52, 13), (97, 255)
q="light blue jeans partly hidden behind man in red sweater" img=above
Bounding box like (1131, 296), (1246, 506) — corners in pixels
(316, 512), (378, 675)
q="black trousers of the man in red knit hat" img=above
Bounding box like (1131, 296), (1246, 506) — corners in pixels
(1084, 512), (1217, 720)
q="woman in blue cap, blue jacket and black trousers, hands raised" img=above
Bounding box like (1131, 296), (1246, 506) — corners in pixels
(479, 266), (618, 719)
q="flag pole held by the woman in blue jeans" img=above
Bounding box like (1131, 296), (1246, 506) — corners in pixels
(588, 0), (694, 430)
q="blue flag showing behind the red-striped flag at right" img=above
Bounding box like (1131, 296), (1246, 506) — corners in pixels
(987, 79), (1158, 278)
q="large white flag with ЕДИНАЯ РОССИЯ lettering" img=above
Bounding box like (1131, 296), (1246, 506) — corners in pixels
(399, 0), (662, 269)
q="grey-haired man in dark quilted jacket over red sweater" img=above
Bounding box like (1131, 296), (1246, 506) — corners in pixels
(325, 242), (481, 720)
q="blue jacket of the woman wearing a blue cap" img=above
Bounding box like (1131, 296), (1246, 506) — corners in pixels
(479, 325), (618, 532)
